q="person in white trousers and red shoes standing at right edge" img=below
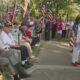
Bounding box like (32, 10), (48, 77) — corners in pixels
(72, 15), (80, 66)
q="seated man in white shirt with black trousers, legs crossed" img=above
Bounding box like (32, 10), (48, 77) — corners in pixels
(2, 24), (32, 69)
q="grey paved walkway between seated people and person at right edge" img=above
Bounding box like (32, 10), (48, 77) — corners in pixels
(25, 41), (80, 80)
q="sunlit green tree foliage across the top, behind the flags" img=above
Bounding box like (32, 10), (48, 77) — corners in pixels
(0, 0), (80, 19)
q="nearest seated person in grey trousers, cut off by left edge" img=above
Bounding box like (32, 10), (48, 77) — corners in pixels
(0, 22), (28, 80)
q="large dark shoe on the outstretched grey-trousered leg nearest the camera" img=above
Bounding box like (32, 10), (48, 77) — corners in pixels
(15, 64), (30, 78)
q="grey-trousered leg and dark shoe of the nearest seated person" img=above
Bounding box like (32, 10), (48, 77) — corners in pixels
(1, 50), (28, 78)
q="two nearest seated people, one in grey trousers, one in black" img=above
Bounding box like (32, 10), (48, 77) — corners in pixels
(0, 21), (29, 80)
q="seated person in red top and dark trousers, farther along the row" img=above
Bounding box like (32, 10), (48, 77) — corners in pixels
(21, 24), (40, 46)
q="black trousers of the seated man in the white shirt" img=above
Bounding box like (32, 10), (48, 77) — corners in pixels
(11, 45), (29, 60)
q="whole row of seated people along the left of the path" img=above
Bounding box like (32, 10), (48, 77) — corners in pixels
(0, 20), (39, 80)
